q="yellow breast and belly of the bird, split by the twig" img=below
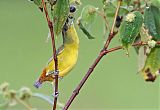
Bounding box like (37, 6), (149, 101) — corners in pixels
(46, 25), (79, 77)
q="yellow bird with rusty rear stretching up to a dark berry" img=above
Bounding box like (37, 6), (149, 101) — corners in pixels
(34, 6), (79, 88)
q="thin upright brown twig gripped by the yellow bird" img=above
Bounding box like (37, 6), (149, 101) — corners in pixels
(42, 0), (59, 110)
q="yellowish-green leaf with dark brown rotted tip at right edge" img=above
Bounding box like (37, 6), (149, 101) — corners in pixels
(140, 47), (160, 81)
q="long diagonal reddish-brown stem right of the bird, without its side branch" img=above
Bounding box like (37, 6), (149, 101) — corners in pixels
(63, 0), (122, 110)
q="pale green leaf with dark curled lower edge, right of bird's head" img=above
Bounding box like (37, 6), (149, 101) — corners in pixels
(78, 5), (97, 39)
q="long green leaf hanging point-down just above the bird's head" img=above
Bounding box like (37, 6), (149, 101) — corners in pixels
(52, 0), (69, 36)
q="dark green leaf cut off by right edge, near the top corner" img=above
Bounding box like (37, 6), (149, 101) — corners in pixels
(144, 5), (160, 41)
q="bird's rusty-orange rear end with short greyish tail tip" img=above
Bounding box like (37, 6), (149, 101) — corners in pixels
(34, 68), (54, 88)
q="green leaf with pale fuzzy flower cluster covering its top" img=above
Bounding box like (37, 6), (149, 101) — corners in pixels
(120, 11), (143, 52)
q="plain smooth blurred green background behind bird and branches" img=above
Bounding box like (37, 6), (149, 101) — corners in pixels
(0, 0), (160, 110)
